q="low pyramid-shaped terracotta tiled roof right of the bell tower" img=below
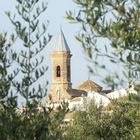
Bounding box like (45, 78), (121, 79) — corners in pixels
(77, 80), (102, 92)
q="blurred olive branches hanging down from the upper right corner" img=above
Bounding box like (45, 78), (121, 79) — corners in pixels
(66, 0), (140, 88)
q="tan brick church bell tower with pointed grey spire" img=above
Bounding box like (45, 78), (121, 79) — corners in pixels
(49, 30), (72, 102)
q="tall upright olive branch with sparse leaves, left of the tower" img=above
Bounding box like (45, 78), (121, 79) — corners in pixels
(6, 0), (51, 101)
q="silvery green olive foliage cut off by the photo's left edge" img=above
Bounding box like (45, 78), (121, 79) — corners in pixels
(0, 33), (18, 107)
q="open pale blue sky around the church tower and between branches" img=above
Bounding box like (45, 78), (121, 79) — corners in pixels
(0, 0), (121, 95)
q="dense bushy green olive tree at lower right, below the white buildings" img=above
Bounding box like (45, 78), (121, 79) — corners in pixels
(65, 95), (140, 140)
